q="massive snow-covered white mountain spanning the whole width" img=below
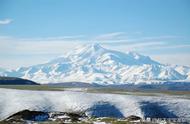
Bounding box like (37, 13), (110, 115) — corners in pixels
(0, 44), (190, 85)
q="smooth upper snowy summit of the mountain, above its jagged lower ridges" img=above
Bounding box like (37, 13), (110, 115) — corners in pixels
(68, 44), (159, 65)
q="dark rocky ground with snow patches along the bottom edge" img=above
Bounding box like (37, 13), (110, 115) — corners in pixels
(0, 110), (146, 124)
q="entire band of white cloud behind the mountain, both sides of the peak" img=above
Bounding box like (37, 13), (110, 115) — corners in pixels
(0, 32), (190, 68)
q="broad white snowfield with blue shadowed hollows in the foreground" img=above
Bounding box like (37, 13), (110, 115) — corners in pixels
(0, 88), (190, 120)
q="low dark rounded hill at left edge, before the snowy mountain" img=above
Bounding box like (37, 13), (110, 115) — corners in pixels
(0, 77), (38, 85)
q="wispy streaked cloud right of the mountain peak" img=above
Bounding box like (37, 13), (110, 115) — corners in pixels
(100, 34), (190, 52)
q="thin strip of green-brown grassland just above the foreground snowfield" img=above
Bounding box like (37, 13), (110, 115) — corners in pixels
(0, 85), (190, 98)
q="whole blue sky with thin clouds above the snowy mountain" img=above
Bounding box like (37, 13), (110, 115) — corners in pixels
(0, 0), (190, 68)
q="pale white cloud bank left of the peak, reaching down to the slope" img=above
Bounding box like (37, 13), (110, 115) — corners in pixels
(0, 37), (83, 68)
